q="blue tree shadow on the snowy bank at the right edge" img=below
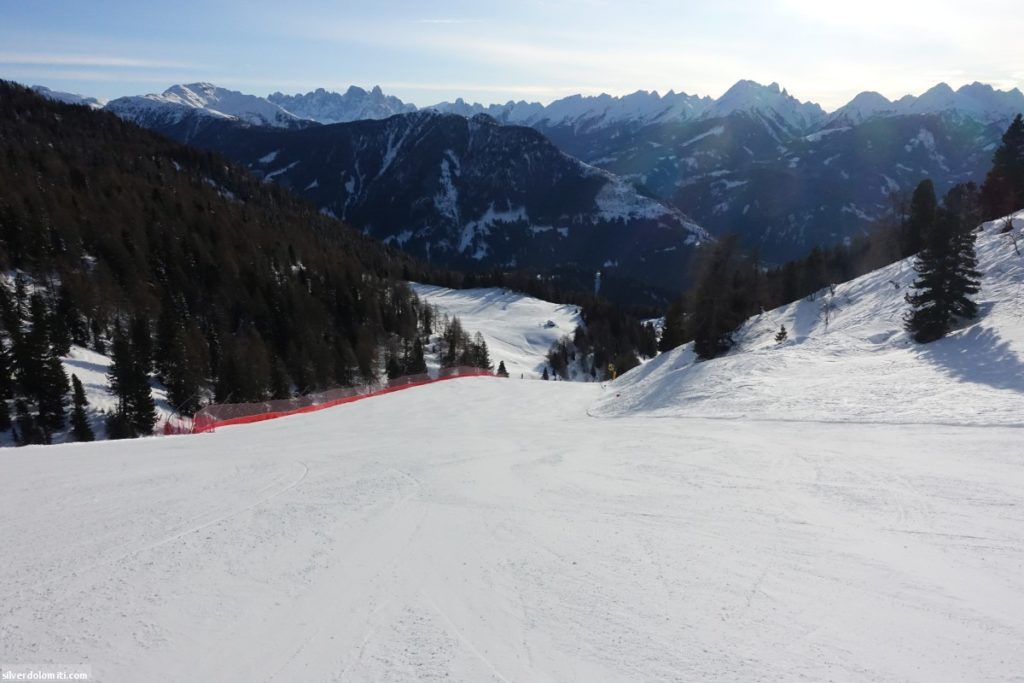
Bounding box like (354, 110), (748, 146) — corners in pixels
(916, 326), (1024, 393)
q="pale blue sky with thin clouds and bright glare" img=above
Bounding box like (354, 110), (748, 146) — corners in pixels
(0, 0), (1024, 111)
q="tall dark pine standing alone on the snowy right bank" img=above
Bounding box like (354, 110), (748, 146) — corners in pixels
(904, 183), (981, 344)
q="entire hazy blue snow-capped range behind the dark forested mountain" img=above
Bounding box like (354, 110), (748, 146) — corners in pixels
(39, 81), (1024, 261)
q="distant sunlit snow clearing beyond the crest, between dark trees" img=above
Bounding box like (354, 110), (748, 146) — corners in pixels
(410, 283), (582, 379)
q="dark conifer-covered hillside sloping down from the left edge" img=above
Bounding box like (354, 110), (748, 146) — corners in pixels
(0, 82), (434, 405)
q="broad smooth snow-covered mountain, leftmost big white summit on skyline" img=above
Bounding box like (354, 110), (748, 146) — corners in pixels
(105, 83), (302, 128)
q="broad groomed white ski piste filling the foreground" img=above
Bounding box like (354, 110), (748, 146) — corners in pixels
(0, 378), (1024, 683)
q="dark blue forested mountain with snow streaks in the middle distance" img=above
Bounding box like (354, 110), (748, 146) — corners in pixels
(149, 111), (708, 289)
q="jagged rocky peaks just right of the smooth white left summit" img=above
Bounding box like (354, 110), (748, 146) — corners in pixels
(267, 85), (416, 124)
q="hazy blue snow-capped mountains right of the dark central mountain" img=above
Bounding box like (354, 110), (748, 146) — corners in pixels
(520, 82), (1024, 261)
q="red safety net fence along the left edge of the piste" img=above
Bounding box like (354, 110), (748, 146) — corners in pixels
(183, 368), (494, 434)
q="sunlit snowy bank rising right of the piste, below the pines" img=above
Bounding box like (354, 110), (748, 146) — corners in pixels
(591, 211), (1024, 425)
